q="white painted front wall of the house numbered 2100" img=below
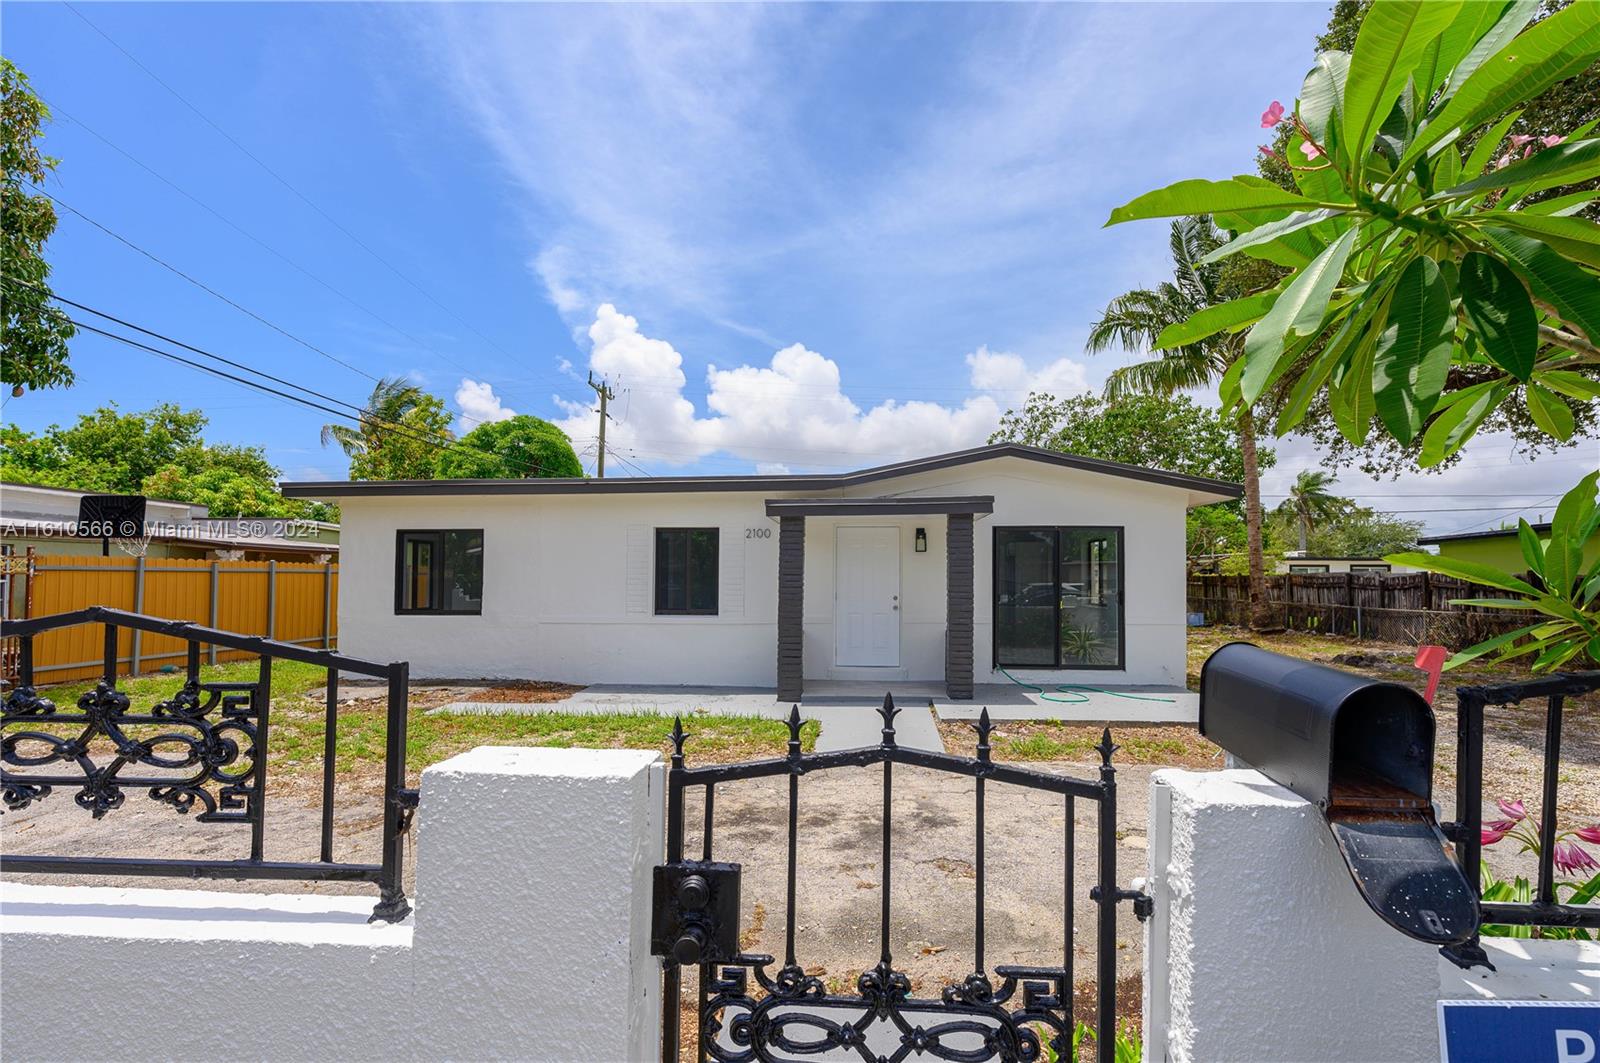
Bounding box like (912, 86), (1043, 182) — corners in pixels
(339, 458), (1187, 687)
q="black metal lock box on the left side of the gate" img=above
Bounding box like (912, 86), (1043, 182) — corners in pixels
(650, 860), (739, 967)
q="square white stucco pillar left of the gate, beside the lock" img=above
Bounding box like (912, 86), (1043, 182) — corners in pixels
(405, 746), (666, 1061)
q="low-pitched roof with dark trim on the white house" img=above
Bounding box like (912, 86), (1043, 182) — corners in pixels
(280, 443), (1243, 504)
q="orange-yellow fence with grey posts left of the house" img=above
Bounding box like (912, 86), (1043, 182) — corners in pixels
(0, 554), (339, 684)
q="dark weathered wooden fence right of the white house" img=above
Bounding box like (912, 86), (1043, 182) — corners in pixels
(1189, 572), (1538, 650)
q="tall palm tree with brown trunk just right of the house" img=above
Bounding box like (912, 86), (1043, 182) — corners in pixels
(1086, 216), (1270, 626)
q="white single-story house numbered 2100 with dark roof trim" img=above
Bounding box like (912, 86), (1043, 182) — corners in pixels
(283, 443), (1240, 700)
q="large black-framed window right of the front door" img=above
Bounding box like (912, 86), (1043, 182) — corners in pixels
(994, 525), (1126, 671)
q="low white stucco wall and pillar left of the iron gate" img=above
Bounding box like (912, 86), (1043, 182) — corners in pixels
(0, 748), (664, 1061)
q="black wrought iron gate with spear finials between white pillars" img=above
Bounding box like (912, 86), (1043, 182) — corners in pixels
(653, 696), (1150, 1063)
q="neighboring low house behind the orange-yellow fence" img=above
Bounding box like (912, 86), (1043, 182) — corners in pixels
(0, 483), (339, 562)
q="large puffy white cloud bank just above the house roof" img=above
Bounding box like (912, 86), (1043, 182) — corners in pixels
(560, 303), (1088, 467)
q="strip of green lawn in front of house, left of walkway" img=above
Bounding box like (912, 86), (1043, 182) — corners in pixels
(35, 661), (821, 781)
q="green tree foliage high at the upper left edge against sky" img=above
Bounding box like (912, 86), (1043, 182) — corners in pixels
(0, 58), (77, 394)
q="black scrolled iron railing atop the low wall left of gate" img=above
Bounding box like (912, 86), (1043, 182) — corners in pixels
(0, 607), (418, 922)
